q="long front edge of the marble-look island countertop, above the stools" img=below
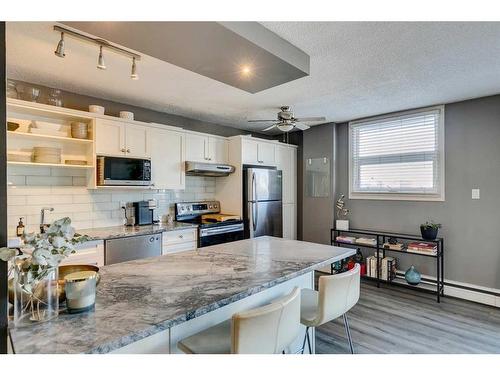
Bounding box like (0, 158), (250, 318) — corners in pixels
(85, 247), (356, 354)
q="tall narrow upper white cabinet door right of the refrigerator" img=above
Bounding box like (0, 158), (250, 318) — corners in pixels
(276, 145), (297, 204)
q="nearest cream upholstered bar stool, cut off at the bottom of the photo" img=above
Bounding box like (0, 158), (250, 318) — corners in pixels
(177, 288), (300, 354)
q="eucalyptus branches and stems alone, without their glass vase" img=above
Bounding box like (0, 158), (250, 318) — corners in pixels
(0, 217), (90, 321)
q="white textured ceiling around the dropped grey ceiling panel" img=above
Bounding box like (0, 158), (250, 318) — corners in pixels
(7, 22), (500, 134)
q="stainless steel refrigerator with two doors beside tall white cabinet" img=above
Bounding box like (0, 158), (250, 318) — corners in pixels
(243, 167), (283, 238)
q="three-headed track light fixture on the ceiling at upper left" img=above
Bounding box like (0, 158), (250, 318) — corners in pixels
(54, 25), (141, 80)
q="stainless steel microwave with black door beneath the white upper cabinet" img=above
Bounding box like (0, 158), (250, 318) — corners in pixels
(97, 156), (151, 186)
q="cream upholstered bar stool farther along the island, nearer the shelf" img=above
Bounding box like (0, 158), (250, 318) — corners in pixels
(300, 264), (360, 354)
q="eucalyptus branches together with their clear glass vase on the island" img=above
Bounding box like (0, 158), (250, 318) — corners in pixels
(0, 217), (89, 327)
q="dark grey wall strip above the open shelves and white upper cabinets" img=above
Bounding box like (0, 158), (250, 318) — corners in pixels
(8, 81), (270, 139)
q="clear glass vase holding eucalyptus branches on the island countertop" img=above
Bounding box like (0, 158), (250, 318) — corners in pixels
(14, 265), (59, 327)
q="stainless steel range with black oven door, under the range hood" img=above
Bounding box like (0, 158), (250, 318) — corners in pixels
(175, 201), (244, 247)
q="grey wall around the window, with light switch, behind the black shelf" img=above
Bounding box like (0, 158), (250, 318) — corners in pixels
(334, 95), (500, 289)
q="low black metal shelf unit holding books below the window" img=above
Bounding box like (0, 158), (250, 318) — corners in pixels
(330, 229), (444, 303)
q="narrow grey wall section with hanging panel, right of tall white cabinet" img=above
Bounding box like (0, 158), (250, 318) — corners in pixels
(299, 124), (335, 244)
